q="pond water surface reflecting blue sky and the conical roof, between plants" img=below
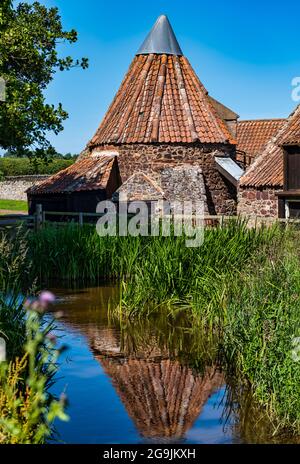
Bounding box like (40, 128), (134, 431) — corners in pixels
(49, 286), (297, 444)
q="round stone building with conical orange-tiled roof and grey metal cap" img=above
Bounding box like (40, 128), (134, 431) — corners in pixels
(28, 16), (243, 215)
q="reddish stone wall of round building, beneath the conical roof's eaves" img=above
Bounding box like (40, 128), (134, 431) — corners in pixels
(94, 143), (237, 215)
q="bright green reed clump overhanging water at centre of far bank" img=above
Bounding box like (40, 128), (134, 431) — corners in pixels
(118, 222), (281, 316)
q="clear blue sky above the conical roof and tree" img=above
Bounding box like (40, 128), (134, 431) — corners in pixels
(22, 0), (300, 153)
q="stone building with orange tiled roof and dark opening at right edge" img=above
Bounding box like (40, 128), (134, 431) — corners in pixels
(238, 106), (300, 218)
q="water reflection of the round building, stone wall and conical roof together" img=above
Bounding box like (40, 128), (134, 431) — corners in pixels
(84, 322), (223, 439)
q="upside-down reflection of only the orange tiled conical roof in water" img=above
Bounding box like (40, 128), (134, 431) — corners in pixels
(95, 355), (222, 439)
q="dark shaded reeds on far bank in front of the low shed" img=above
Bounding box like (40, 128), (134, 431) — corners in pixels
(28, 224), (145, 284)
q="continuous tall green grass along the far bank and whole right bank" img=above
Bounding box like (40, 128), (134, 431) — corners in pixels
(5, 222), (300, 433)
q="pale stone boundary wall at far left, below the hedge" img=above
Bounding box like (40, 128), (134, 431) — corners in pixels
(0, 175), (49, 201)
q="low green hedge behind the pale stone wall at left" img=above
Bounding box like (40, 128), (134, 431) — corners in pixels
(0, 158), (74, 177)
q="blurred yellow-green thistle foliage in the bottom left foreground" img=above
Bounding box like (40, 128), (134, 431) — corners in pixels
(0, 311), (68, 444)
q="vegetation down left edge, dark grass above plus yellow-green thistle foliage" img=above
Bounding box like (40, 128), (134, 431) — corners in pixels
(0, 229), (66, 444)
